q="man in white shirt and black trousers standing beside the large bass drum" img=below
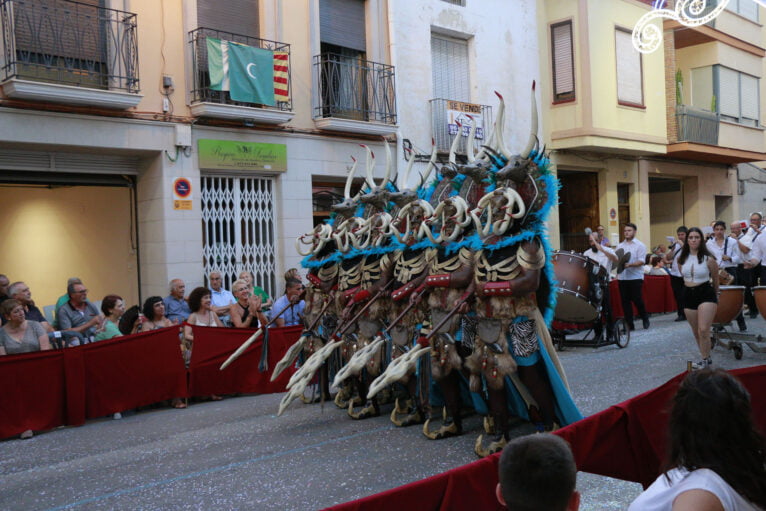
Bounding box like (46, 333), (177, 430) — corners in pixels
(615, 223), (649, 330)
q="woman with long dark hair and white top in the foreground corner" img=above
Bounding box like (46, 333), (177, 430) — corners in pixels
(628, 369), (766, 511)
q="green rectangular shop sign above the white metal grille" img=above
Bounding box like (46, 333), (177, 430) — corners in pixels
(197, 139), (287, 172)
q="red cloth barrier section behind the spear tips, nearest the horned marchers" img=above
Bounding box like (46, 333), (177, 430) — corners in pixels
(189, 326), (302, 396)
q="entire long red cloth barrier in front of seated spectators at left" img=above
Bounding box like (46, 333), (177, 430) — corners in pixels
(0, 326), (301, 438)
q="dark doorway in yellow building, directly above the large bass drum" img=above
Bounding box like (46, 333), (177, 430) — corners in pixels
(558, 170), (599, 252)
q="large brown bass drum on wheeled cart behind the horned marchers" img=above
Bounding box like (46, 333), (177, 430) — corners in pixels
(551, 250), (630, 351)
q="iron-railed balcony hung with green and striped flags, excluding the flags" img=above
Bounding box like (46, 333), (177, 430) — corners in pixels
(189, 27), (295, 124)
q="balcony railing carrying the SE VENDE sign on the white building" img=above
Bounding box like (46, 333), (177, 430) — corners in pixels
(429, 98), (492, 154)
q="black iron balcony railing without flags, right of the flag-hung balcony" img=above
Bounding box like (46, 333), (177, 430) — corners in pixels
(314, 53), (396, 124)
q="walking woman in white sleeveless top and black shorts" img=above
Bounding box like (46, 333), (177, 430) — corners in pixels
(678, 227), (720, 369)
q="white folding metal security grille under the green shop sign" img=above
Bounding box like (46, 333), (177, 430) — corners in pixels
(201, 176), (277, 297)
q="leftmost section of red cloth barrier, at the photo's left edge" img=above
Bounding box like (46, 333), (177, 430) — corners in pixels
(0, 351), (66, 438)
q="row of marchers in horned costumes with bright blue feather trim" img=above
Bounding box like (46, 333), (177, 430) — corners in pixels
(258, 85), (581, 456)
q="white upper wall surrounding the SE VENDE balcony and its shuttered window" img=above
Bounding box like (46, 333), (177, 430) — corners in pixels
(389, 0), (543, 188)
